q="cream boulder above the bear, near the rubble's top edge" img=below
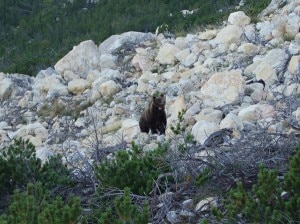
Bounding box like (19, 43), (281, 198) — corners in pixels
(155, 43), (180, 65)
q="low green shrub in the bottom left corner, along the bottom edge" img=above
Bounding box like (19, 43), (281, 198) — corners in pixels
(0, 182), (81, 224)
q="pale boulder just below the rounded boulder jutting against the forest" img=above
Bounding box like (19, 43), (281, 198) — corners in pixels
(214, 25), (243, 46)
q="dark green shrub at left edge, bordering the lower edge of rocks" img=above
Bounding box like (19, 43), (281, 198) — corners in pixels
(0, 139), (73, 197)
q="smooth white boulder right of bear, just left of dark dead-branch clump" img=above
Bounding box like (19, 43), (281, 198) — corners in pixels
(192, 120), (220, 144)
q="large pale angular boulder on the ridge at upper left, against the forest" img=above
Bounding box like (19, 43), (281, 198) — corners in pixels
(54, 40), (100, 78)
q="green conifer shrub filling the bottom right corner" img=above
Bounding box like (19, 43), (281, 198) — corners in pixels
(225, 146), (300, 224)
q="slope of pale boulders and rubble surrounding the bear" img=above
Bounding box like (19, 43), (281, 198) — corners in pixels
(0, 0), (300, 220)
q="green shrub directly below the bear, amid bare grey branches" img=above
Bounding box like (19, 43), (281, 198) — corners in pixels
(96, 144), (169, 194)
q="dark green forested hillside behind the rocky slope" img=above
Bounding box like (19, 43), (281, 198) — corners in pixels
(0, 0), (270, 76)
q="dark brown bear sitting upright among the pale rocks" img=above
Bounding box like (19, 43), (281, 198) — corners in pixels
(139, 92), (167, 134)
